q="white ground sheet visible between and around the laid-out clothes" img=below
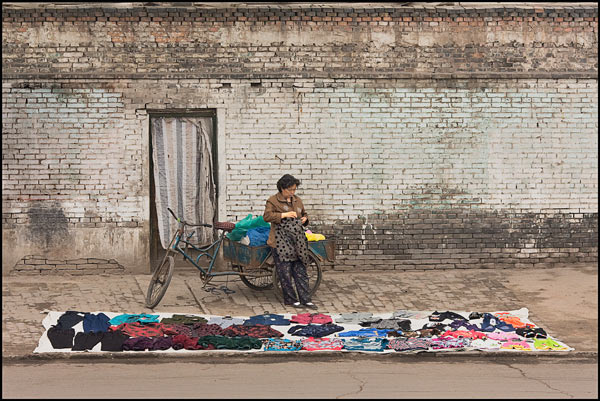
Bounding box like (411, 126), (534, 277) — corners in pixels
(33, 308), (574, 354)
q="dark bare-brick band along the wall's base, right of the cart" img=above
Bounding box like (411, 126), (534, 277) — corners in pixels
(313, 210), (598, 271)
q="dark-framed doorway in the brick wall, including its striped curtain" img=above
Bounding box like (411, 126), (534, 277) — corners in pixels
(149, 110), (217, 271)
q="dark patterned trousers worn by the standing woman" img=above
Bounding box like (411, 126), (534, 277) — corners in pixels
(273, 249), (310, 305)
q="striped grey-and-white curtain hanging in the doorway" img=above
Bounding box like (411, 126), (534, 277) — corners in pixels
(152, 117), (215, 249)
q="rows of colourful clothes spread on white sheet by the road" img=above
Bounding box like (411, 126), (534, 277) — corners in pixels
(34, 308), (573, 353)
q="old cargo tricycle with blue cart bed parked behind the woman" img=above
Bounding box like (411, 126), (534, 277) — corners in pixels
(146, 208), (334, 309)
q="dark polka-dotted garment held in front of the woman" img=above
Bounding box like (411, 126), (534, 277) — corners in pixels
(275, 217), (310, 266)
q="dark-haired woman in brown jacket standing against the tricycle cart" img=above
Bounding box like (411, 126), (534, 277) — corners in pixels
(263, 174), (317, 309)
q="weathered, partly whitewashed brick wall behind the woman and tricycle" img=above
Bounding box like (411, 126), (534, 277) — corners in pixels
(2, 6), (598, 271)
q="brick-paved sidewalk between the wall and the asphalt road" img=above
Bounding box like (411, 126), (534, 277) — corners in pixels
(2, 264), (598, 360)
